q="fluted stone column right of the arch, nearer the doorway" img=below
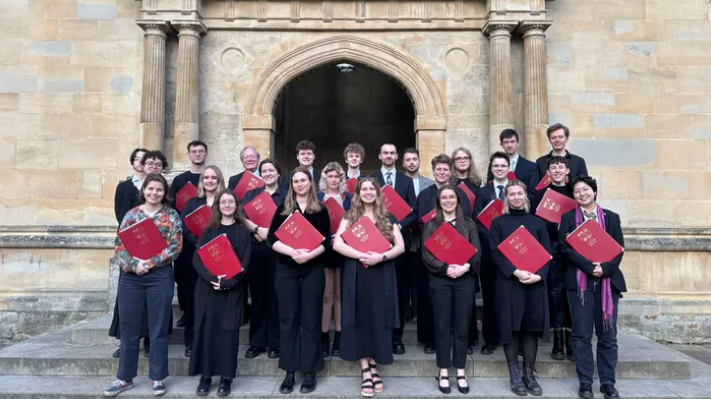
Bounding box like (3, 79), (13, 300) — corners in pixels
(484, 22), (515, 152)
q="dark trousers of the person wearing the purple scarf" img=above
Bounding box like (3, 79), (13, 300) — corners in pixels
(568, 288), (620, 385)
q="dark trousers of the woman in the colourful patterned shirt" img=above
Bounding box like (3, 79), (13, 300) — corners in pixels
(116, 266), (174, 381)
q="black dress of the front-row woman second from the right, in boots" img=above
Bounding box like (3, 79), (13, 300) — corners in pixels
(489, 209), (551, 344)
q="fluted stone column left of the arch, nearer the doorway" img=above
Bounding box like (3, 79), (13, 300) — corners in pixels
(173, 23), (205, 170)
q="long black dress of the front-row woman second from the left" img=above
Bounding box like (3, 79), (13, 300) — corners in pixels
(189, 225), (251, 379)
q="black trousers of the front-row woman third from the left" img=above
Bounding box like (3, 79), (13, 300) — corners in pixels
(275, 264), (326, 373)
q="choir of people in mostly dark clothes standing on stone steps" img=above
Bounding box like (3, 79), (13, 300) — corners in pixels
(104, 124), (626, 399)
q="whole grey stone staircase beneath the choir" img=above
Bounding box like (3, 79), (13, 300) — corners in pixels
(0, 313), (711, 399)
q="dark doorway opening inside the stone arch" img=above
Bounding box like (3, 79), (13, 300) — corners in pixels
(274, 63), (416, 173)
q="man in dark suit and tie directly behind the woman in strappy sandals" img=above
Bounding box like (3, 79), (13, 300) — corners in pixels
(375, 144), (417, 355)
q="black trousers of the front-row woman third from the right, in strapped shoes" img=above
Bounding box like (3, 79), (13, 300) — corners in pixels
(429, 273), (476, 369)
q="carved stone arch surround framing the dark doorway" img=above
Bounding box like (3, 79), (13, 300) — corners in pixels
(243, 36), (446, 172)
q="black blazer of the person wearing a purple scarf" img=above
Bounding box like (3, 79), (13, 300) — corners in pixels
(558, 209), (627, 292)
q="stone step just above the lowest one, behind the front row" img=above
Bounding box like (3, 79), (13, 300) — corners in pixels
(0, 334), (691, 379)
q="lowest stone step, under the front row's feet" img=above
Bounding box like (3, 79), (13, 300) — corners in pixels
(0, 375), (711, 399)
